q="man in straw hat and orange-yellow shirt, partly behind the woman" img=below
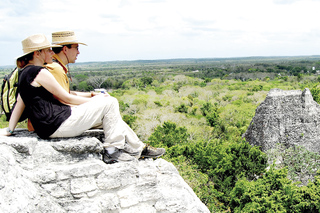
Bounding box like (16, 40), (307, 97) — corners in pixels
(46, 31), (165, 161)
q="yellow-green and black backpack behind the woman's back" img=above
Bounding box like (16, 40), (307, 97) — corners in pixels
(1, 67), (27, 121)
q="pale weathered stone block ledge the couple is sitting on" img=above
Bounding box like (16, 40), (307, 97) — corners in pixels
(0, 130), (209, 213)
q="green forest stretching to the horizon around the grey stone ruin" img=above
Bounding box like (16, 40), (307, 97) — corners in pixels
(0, 56), (320, 212)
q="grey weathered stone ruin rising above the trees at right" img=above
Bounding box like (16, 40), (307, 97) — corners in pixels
(244, 89), (320, 152)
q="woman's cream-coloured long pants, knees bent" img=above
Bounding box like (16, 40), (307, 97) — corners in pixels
(50, 95), (145, 153)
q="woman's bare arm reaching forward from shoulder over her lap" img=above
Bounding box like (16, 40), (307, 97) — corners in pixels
(32, 69), (90, 105)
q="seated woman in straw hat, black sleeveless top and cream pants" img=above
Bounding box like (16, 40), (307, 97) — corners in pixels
(2, 34), (165, 163)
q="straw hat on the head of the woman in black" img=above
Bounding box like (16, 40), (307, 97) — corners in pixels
(17, 34), (61, 59)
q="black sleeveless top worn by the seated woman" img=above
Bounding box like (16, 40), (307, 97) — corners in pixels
(18, 65), (71, 138)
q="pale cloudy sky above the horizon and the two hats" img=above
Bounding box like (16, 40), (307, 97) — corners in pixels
(0, 0), (320, 66)
